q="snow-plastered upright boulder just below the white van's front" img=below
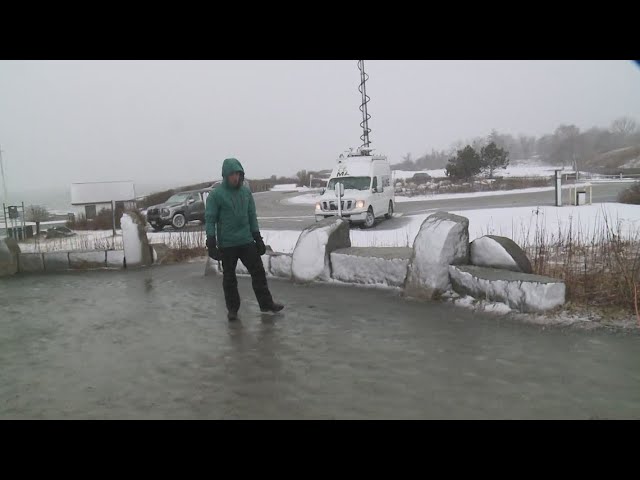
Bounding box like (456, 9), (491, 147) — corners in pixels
(291, 218), (351, 282)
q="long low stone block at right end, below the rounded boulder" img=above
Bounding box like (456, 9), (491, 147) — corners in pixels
(449, 265), (565, 312)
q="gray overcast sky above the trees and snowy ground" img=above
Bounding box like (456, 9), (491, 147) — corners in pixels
(0, 61), (640, 194)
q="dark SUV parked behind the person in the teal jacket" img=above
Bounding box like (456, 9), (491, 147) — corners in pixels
(147, 188), (211, 232)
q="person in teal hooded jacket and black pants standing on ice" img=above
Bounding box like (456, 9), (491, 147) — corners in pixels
(205, 158), (284, 320)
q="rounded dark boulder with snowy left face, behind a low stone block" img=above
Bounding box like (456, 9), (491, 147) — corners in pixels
(471, 235), (533, 273)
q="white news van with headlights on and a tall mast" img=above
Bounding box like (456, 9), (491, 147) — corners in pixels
(315, 149), (395, 228)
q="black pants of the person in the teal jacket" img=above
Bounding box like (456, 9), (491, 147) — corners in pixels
(220, 242), (273, 312)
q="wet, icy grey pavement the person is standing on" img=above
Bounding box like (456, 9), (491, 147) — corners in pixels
(0, 264), (640, 419)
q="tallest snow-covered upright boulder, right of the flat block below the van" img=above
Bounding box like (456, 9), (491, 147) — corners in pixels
(405, 212), (469, 299)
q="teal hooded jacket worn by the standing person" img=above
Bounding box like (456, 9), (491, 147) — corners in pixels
(205, 158), (260, 248)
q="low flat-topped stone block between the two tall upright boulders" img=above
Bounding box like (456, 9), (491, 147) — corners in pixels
(331, 247), (412, 287)
